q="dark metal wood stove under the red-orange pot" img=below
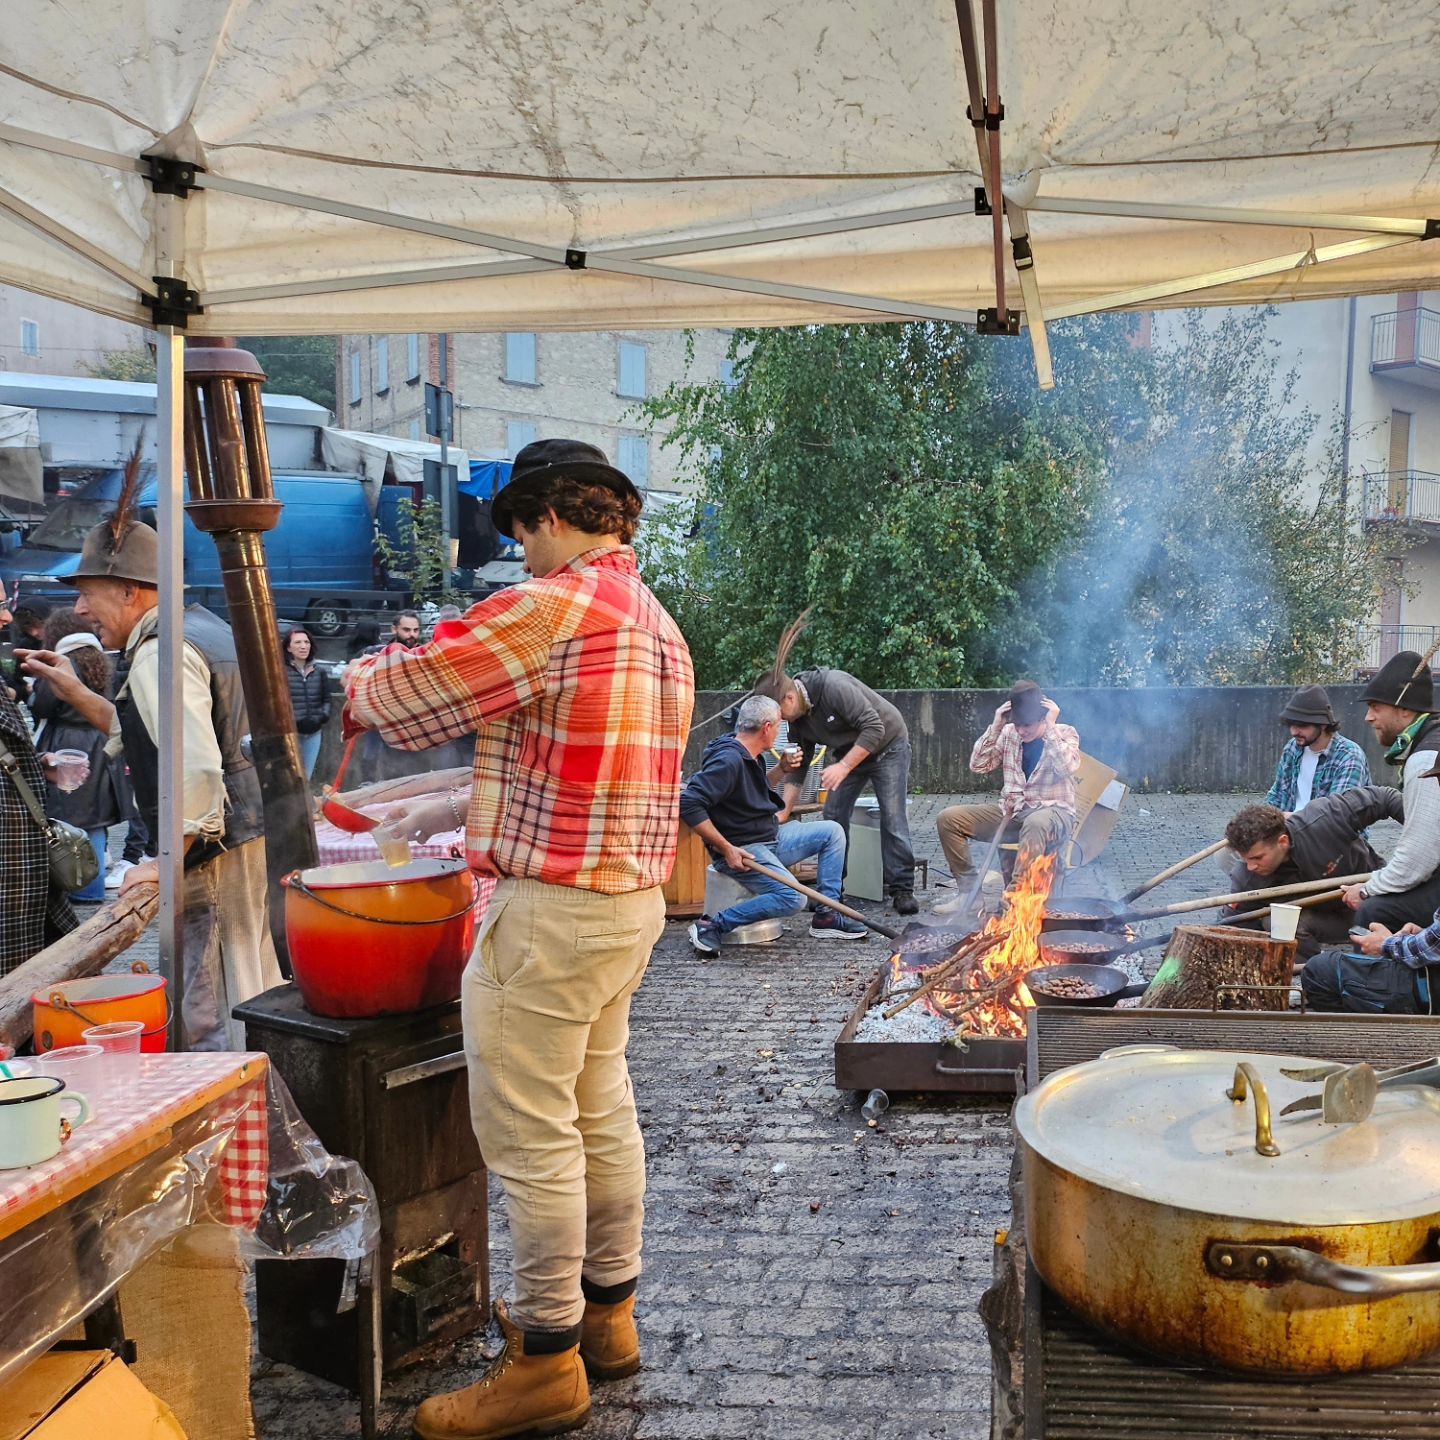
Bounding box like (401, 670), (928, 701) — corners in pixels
(235, 985), (490, 1411)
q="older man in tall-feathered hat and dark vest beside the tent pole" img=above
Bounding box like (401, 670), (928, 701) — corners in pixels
(23, 448), (281, 1050)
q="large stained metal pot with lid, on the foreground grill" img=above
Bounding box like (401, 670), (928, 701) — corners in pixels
(1015, 1051), (1440, 1374)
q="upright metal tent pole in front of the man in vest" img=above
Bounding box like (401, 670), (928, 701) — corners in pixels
(150, 325), (184, 1050)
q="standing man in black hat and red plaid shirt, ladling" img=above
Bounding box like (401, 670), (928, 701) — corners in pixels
(348, 439), (694, 1440)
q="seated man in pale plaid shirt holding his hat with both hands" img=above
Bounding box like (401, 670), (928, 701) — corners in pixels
(935, 680), (1080, 914)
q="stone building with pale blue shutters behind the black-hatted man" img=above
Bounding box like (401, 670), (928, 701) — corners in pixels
(336, 330), (730, 491)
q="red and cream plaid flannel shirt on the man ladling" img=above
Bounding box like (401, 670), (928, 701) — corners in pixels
(348, 546), (696, 894)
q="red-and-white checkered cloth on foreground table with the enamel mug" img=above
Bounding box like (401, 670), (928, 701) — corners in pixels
(0, 1053), (269, 1234)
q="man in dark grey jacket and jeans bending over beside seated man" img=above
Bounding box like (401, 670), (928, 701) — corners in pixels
(755, 668), (920, 914)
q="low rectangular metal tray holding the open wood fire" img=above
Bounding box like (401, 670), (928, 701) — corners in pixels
(835, 960), (1025, 1094)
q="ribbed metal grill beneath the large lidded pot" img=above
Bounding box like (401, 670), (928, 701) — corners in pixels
(1013, 1009), (1440, 1440)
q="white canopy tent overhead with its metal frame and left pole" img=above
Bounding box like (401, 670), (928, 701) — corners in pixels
(0, 0), (1440, 984)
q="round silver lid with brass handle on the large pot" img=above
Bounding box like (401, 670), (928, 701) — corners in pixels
(1015, 1050), (1440, 1225)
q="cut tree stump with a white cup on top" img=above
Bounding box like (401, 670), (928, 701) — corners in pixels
(1140, 924), (1295, 1009)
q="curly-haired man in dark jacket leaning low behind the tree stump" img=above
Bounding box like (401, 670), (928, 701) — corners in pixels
(1220, 785), (1405, 959)
